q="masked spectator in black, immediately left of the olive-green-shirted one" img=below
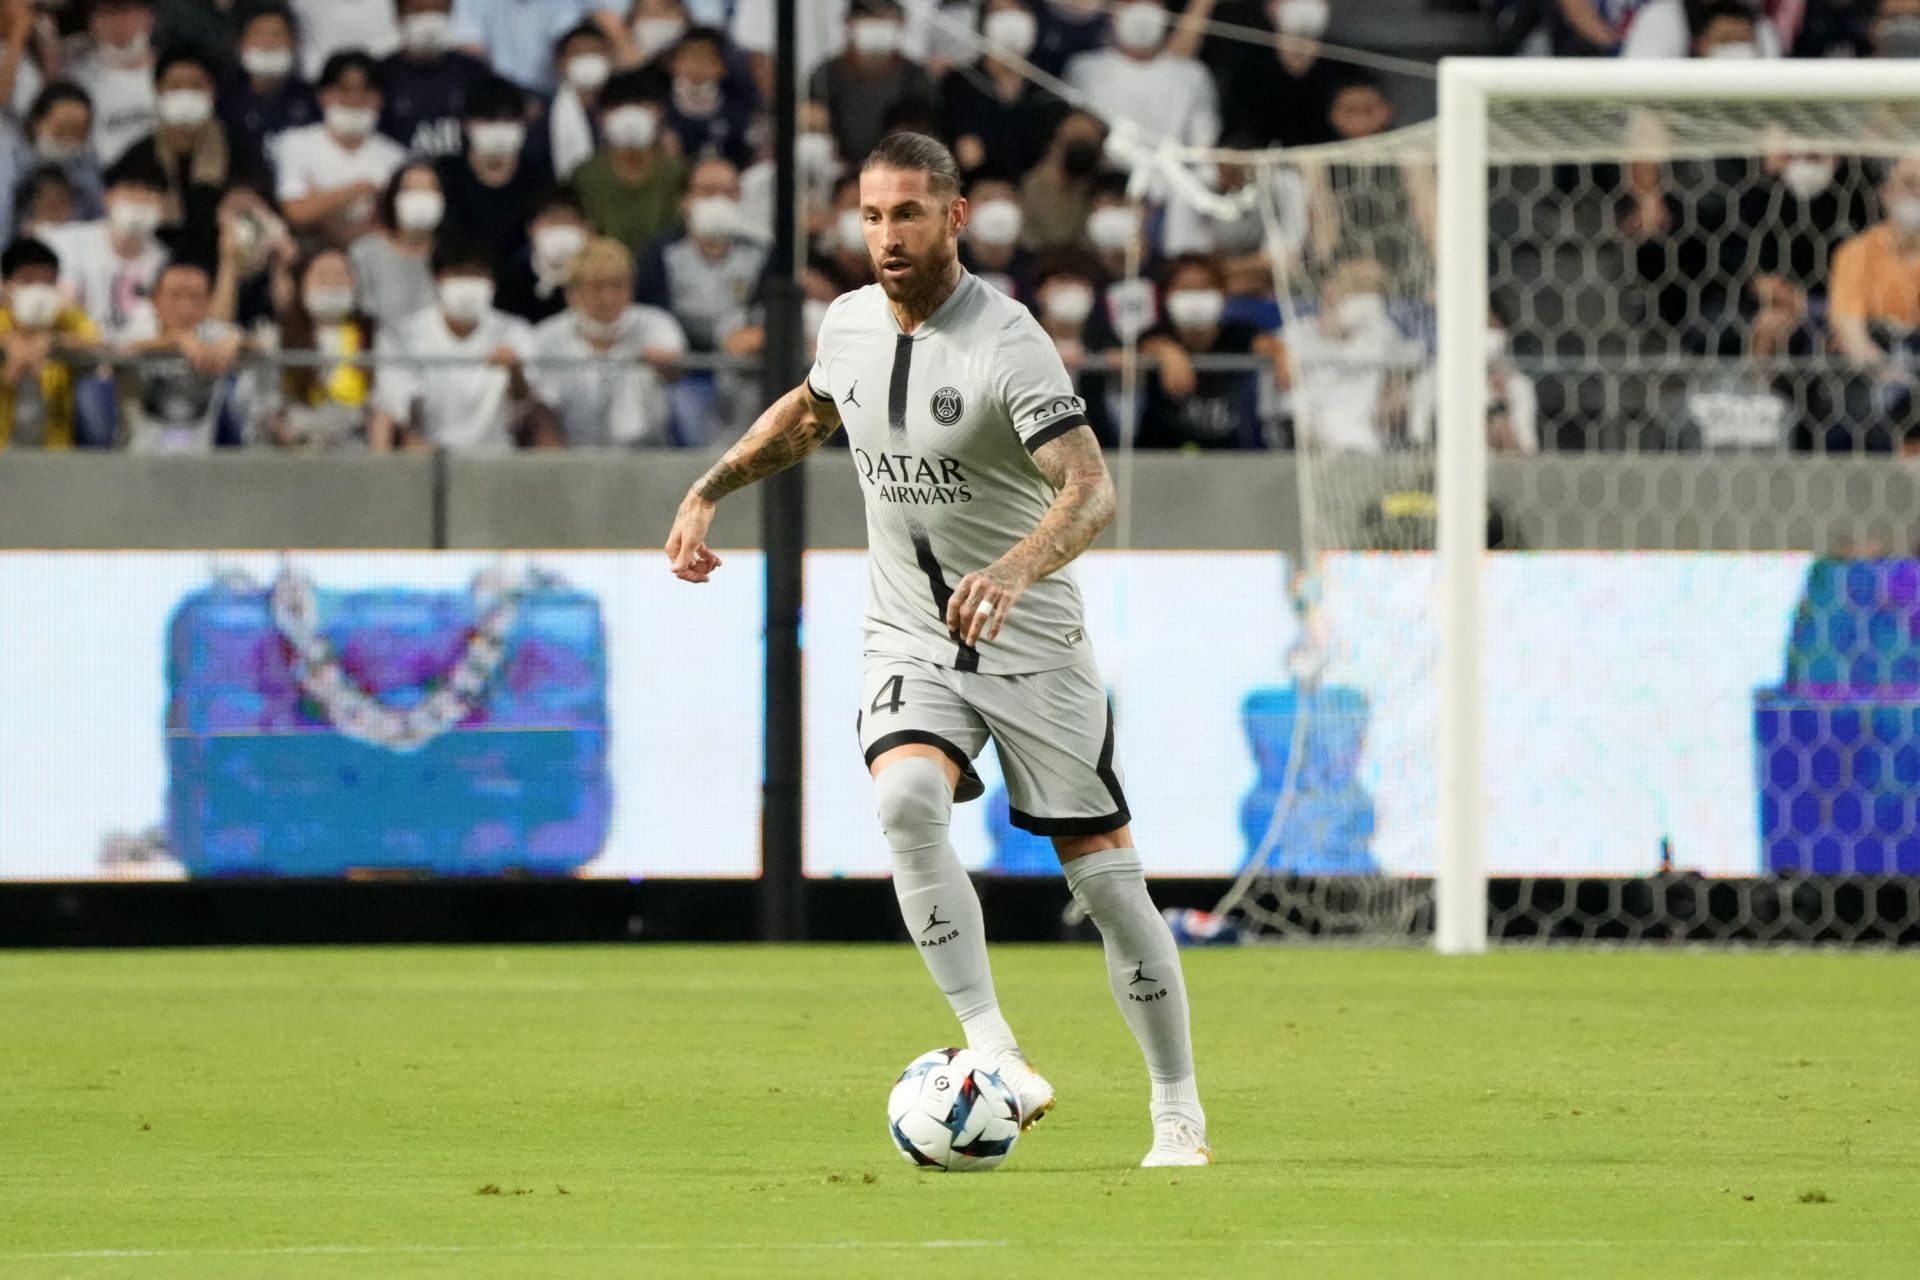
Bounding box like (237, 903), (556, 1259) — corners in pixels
(434, 75), (553, 269)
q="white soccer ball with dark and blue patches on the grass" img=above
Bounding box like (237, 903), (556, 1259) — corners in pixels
(887, 1050), (1020, 1173)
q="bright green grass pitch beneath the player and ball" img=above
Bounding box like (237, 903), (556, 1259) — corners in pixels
(0, 944), (1920, 1280)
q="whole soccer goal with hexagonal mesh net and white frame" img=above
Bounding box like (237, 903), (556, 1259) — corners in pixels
(1162, 61), (1920, 950)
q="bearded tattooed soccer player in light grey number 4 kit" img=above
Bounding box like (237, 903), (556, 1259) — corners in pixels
(666, 132), (1213, 1167)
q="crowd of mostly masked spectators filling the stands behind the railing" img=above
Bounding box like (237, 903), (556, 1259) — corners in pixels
(0, 0), (1920, 451)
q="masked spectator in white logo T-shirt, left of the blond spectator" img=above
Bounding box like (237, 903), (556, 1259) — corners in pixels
(367, 240), (553, 453)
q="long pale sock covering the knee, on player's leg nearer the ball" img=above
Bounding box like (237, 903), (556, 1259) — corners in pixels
(874, 756), (1014, 1052)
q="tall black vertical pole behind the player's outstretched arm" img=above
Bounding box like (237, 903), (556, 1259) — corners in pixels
(760, 0), (806, 942)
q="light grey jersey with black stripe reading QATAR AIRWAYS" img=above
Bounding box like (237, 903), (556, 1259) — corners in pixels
(806, 274), (1087, 676)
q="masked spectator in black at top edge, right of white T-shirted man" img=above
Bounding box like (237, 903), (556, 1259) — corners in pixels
(1221, 0), (1342, 148)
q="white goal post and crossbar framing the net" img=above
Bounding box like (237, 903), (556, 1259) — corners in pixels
(1434, 58), (1920, 954)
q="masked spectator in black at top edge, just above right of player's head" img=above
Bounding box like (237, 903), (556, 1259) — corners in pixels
(941, 0), (1066, 178)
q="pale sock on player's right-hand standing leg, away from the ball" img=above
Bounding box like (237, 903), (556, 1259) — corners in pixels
(1066, 848), (1200, 1111)
